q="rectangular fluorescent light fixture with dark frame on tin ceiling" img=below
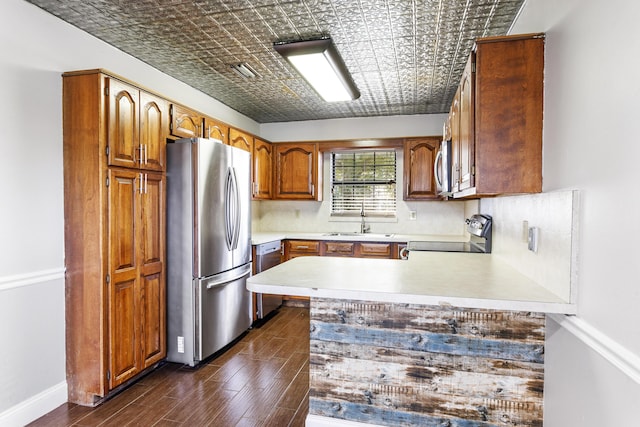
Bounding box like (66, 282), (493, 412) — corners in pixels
(273, 38), (360, 102)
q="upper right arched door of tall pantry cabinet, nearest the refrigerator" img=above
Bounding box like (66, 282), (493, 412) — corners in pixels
(140, 92), (169, 171)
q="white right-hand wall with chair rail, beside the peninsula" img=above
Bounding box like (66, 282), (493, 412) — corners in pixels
(512, 0), (640, 427)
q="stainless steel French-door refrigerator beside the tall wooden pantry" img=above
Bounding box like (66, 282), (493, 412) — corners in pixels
(167, 138), (253, 366)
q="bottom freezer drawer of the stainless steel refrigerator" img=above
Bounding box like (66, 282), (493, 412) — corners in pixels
(194, 263), (253, 363)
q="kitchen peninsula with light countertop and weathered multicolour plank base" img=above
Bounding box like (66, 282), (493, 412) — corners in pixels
(247, 252), (575, 426)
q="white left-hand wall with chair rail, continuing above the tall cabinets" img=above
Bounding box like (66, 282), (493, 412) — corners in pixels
(0, 0), (259, 426)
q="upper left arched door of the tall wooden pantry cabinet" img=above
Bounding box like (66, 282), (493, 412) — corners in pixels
(106, 78), (141, 168)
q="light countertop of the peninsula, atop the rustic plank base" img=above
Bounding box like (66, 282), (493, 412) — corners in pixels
(247, 252), (576, 314)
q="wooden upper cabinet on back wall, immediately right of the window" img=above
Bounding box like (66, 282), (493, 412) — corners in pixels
(403, 137), (440, 200)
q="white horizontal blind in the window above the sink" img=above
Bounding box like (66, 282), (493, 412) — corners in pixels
(331, 150), (396, 216)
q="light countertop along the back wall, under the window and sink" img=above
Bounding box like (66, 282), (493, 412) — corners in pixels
(251, 231), (469, 245)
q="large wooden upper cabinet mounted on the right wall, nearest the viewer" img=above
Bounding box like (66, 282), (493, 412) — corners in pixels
(452, 34), (545, 198)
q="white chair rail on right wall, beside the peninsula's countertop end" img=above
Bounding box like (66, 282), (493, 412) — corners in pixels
(549, 314), (640, 384)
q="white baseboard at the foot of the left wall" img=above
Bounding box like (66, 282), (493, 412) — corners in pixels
(0, 381), (67, 427)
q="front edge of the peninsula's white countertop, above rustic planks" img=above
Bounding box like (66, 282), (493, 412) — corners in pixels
(247, 278), (577, 314)
